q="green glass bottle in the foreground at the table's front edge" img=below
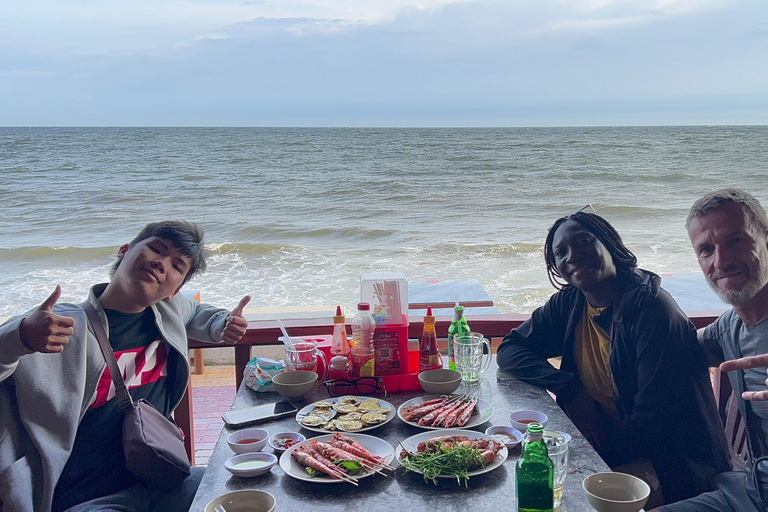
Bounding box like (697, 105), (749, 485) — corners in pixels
(515, 423), (555, 512)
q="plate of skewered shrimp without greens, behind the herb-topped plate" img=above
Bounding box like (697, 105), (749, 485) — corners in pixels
(397, 395), (493, 430)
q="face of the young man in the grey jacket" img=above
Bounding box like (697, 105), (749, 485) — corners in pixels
(112, 237), (190, 306)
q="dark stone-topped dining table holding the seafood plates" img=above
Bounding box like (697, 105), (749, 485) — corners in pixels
(190, 355), (610, 512)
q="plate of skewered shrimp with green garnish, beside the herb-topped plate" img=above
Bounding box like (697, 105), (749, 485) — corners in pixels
(280, 432), (395, 485)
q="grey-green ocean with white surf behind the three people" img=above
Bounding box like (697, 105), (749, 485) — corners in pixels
(0, 126), (768, 316)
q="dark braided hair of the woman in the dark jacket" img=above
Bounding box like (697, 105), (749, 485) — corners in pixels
(544, 212), (637, 290)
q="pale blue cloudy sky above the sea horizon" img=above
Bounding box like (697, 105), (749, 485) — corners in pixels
(0, 0), (768, 127)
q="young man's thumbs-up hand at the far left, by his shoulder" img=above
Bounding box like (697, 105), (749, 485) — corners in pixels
(19, 285), (75, 354)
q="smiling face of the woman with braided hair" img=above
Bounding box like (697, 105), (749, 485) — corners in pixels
(552, 220), (616, 291)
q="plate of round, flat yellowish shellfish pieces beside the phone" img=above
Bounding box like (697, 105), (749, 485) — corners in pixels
(296, 395), (395, 434)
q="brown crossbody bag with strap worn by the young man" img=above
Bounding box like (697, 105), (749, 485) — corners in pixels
(82, 302), (190, 489)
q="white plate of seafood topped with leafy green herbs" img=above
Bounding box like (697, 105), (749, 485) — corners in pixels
(396, 429), (509, 485)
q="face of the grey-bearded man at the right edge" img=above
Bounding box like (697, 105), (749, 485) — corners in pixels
(688, 203), (768, 304)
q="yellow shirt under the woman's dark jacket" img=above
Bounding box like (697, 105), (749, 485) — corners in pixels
(573, 301), (619, 418)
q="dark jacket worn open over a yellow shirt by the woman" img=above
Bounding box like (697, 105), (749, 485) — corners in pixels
(497, 269), (731, 503)
